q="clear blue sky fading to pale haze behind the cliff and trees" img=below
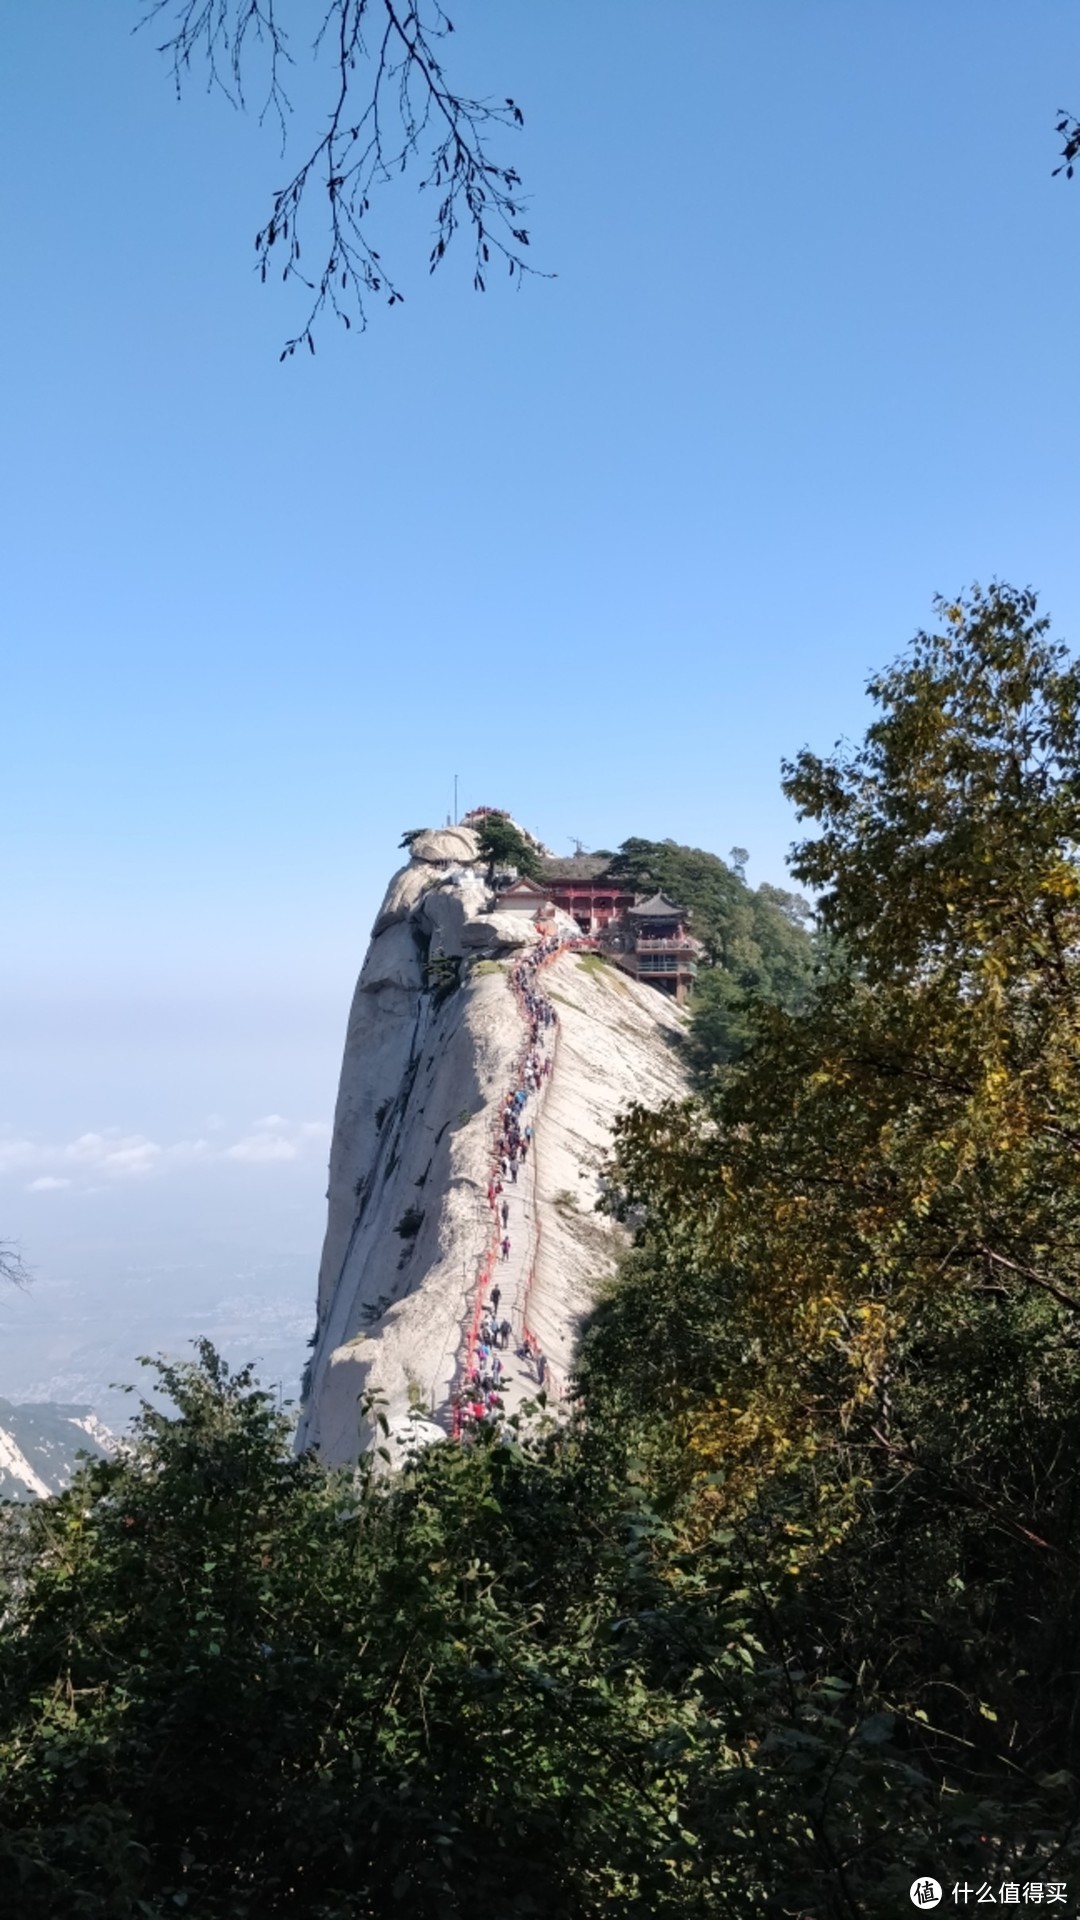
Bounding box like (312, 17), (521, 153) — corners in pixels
(0, 0), (1080, 1394)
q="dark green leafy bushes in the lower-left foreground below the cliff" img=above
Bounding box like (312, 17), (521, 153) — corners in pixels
(0, 1348), (749, 1920)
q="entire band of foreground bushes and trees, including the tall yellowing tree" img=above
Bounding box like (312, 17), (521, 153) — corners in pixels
(0, 588), (1080, 1920)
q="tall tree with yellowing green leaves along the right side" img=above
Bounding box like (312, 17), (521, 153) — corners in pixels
(599, 588), (1080, 1912)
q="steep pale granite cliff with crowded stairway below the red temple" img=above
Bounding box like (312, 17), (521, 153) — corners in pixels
(300, 828), (684, 1463)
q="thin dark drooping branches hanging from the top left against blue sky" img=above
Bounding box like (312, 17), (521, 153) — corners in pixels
(138, 0), (536, 359)
